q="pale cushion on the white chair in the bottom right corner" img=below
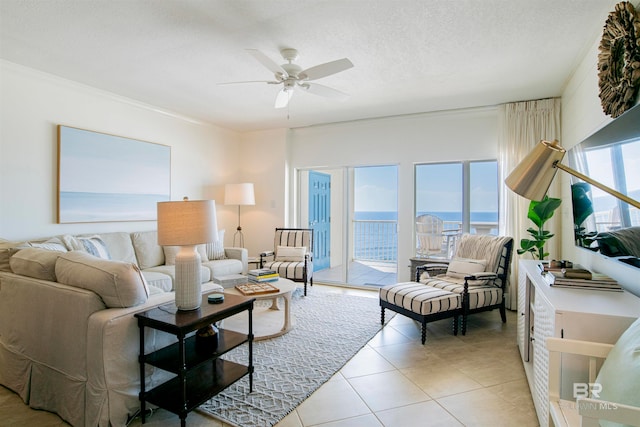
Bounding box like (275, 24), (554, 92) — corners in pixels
(594, 319), (640, 427)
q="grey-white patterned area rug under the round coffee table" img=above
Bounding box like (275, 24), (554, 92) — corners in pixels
(199, 289), (392, 427)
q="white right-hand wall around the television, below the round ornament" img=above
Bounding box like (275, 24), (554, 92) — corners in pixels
(556, 20), (640, 296)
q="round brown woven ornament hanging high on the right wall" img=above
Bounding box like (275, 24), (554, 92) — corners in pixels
(598, 1), (640, 117)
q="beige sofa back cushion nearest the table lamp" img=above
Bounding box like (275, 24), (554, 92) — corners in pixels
(55, 251), (149, 308)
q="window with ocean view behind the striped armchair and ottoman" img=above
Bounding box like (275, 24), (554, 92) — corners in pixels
(415, 160), (498, 241)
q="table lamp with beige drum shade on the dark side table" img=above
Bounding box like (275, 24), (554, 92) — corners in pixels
(158, 198), (218, 310)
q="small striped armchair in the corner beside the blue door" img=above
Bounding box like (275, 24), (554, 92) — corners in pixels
(260, 228), (313, 296)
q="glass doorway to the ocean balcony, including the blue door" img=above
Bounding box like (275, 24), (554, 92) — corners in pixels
(298, 166), (398, 287)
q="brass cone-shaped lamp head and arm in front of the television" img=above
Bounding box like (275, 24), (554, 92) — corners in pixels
(505, 140), (640, 209)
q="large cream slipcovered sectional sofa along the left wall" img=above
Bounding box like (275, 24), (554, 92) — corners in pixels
(0, 231), (247, 426)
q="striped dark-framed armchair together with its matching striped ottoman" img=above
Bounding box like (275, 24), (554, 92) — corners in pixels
(380, 234), (513, 344)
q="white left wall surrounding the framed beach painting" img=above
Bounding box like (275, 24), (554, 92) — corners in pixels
(0, 61), (239, 244)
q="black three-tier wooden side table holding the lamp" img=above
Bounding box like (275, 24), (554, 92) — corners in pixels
(135, 295), (255, 427)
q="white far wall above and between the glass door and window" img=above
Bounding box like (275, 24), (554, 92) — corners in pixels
(290, 108), (497, 280)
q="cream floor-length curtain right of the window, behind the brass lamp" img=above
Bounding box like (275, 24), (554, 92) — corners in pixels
(498, 98), (560, 310)
